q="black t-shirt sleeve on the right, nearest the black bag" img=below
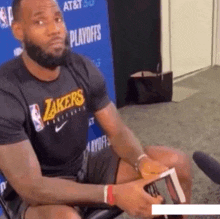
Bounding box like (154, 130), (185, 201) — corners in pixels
(83, 57), (111, 112)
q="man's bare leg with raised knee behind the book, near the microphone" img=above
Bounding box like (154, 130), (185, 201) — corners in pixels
(116, 146), (192, 204)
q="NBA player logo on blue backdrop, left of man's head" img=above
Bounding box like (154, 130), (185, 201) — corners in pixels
(0, 6), (13, 29)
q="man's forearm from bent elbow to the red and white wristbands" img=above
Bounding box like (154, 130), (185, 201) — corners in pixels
(19, 177), (104, 205)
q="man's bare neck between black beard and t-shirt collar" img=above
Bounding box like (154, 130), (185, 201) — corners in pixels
(22, 51), (60, 81)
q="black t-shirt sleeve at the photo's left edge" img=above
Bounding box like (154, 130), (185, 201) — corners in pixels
(0, 89), (28, 145)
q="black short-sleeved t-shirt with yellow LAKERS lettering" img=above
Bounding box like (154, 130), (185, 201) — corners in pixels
(0, 54), (110, 176)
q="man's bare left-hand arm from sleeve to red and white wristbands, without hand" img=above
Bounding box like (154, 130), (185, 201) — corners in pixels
(0, 140), (104, 205)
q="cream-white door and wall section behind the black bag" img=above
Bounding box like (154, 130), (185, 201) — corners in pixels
(161, 0), (214, 77)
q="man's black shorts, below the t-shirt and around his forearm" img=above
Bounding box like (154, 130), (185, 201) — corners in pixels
(1, 146), (120, 219)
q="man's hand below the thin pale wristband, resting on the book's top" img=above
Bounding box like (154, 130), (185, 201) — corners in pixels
(139, 157), (168, 179)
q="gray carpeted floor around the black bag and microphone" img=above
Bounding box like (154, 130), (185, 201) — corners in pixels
(116, 66), (220, 219)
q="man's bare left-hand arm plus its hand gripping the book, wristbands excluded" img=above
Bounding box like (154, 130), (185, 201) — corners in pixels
(0, 127), (162, 217)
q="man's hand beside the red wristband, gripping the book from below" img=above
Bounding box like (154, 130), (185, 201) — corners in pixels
(113, 175), (163, 218)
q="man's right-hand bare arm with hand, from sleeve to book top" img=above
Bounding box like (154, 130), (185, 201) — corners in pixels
(95, 103), (167, 177)
